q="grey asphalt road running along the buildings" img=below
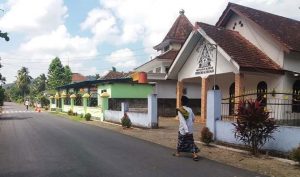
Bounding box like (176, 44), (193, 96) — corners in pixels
(0, 103), (262, 177)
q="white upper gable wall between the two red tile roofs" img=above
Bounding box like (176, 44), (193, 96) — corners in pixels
(226, 14), (284, 67)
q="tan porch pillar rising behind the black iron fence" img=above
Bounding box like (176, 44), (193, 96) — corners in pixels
(234, 73), (245, 110)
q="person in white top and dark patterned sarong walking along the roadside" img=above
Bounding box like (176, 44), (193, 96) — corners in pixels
(174, 96), (199, 161)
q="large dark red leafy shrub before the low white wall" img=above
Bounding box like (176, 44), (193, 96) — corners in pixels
(233, 100), (278, 155)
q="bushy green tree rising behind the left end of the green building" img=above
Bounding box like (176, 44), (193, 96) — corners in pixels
(47, 57), (72, 89)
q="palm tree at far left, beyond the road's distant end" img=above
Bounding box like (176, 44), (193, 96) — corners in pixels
(16, 67), (32, 96)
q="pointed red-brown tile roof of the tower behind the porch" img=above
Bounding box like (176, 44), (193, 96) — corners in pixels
(153, 11), (193, 50)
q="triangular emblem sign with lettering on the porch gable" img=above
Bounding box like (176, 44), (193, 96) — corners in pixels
(195, 41), (216, 77)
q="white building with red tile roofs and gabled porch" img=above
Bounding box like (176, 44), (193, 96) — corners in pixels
(165, 3), (300, 122)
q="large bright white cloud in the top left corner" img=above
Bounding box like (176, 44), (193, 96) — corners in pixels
(0, 0), (67, 35)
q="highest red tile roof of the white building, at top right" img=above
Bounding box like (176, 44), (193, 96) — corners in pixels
(216, 3), (300, 51)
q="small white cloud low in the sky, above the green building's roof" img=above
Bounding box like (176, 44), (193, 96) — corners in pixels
(106, 48), (138, 69)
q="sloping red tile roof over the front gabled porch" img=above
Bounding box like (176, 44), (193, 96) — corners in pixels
(198, 22), (281, 72)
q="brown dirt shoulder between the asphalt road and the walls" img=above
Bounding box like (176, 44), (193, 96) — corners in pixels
(52, 112), (300, 177)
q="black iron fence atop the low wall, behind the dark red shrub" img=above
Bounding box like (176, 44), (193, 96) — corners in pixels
(221, 92), (300, 126)
